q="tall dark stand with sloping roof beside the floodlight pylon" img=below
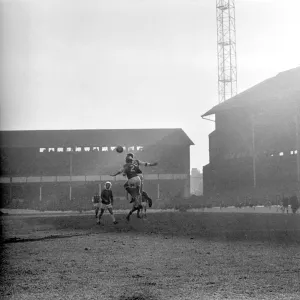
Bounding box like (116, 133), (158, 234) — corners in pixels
(202, 67), (300, 203)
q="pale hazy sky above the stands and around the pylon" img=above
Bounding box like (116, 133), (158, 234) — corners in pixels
(0, 0), (300, 170)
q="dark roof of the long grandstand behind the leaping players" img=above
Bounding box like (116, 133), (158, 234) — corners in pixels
(0, 128), (193, 148)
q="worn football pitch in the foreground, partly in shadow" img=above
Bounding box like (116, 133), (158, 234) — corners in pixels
(1, 212), (300, 300)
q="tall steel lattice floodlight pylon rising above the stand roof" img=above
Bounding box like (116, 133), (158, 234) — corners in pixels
(217, 0), (237, 103)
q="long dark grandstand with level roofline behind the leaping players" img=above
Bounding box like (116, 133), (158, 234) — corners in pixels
(0, 128), (193, 210)
